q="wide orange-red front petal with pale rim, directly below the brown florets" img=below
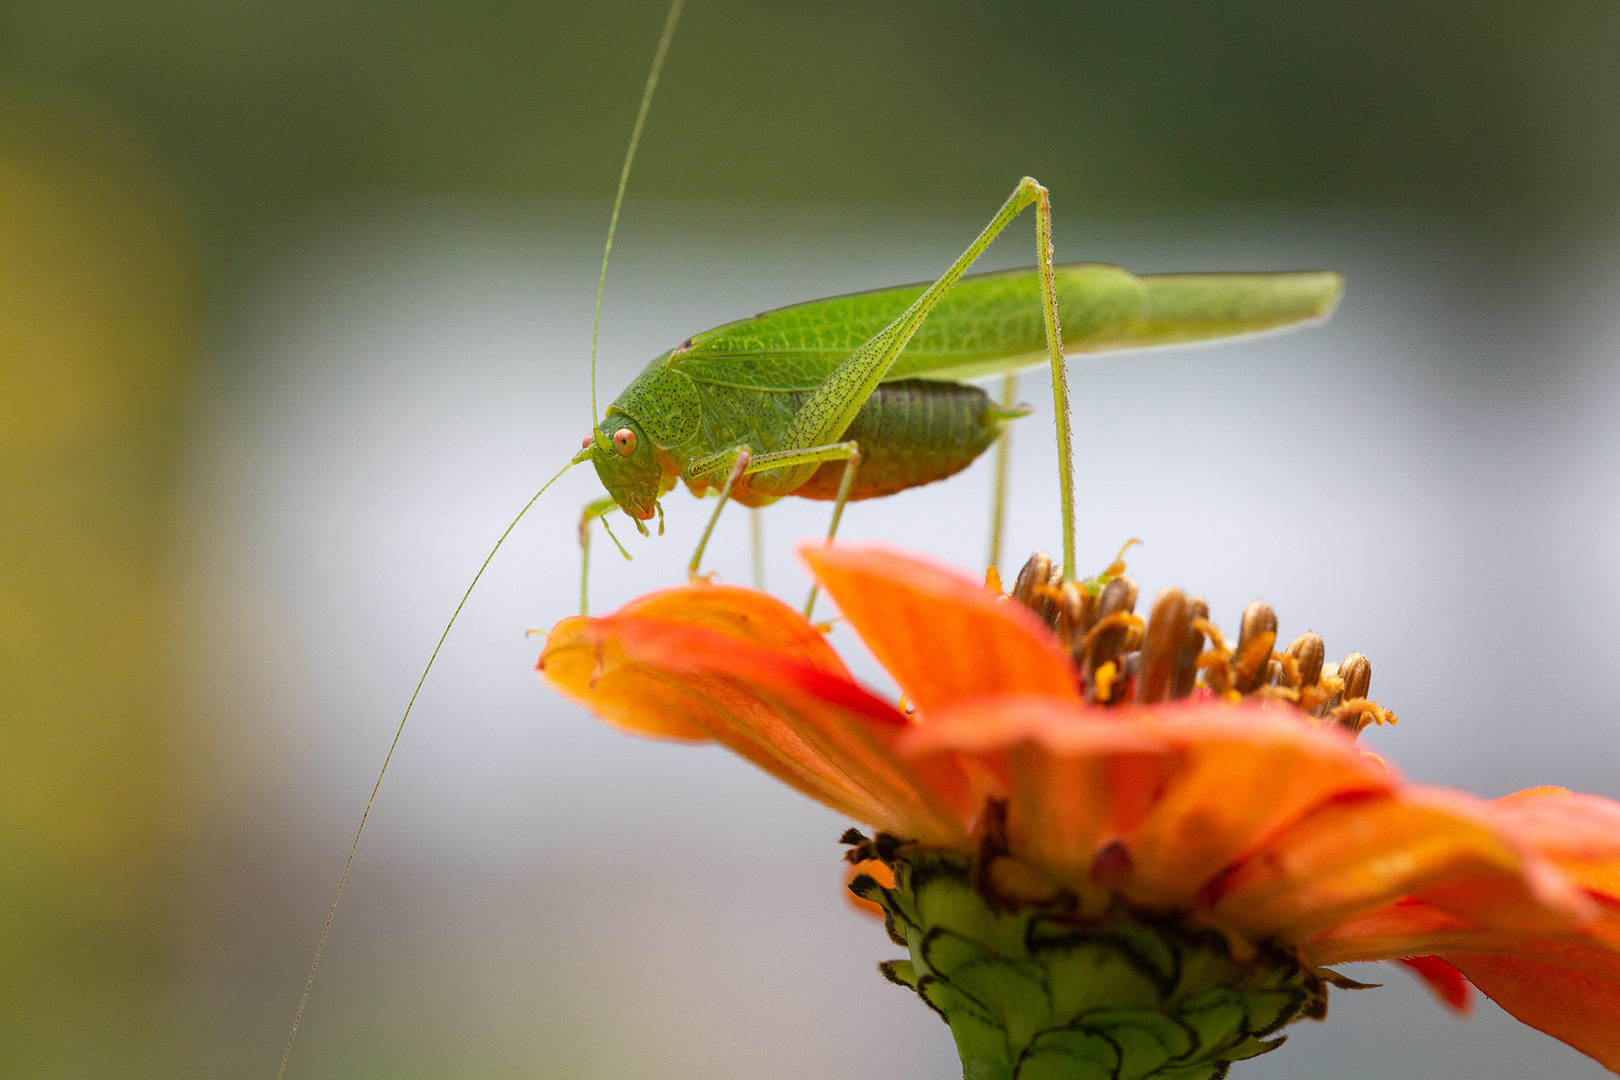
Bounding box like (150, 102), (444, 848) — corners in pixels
(901, 695), (1395, 907)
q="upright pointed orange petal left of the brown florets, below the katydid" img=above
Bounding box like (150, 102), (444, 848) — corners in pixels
(799, 544), (1079, 717)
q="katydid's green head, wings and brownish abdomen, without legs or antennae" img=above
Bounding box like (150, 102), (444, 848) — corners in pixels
(586, 262), (1341, 520)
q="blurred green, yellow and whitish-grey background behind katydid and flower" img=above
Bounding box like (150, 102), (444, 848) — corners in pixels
(0, 0), (1620, 1080)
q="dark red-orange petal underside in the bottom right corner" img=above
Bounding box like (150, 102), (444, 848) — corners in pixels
(1447, 954), (1620, 1072)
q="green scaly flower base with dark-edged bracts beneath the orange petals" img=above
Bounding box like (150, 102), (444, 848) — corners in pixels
(851, 837), (1348, 1080)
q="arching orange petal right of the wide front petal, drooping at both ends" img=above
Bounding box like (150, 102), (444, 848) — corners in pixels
(1215, 787), (1592, 955)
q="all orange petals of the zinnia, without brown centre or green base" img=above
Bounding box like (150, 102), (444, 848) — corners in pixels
(539, 546), (1620, 1075)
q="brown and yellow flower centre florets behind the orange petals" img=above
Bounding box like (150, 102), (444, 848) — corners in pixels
(985, 551), (1396, 733)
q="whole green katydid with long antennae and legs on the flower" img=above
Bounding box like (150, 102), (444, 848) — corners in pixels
(277, 0), (1341, 1077)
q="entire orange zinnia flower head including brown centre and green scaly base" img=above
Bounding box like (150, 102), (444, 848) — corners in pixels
(539, 546), (1620, 1080)
